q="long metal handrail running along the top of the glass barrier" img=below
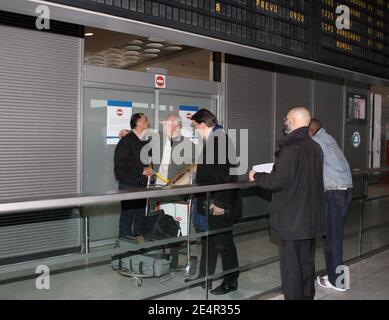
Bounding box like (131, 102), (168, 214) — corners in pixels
(0, 167), (389, 215)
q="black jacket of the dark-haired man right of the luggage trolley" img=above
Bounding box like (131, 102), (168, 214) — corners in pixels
(196, 127), (240, 217)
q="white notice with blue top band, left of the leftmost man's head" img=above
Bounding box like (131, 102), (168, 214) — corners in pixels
(106, 100), (132, 145)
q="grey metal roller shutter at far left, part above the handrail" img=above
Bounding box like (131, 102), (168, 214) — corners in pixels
(0, 25), (81, 201)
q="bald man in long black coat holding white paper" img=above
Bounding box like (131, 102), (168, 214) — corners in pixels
(249, 107), (325, 300)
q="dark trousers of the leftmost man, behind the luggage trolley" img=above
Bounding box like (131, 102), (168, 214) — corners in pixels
(119, 183), (146, 238)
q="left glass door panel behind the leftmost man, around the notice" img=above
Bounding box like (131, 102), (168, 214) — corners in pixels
(82, 88), (154, 241)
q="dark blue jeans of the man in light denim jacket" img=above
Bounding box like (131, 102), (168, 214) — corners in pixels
(324, 189), (352, 286)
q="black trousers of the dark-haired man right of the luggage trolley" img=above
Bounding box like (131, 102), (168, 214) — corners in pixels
(199, 216), (239, 284)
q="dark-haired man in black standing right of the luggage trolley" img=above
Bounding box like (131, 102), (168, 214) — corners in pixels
(191, 109), (239, 295)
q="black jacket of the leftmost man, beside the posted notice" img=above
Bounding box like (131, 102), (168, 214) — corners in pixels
(114, 131), (148, 187)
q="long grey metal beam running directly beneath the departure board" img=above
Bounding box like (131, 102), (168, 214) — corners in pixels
(2, 0), (389, 86)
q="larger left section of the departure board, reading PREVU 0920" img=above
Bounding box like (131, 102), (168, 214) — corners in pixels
(46, 0), (313, 59)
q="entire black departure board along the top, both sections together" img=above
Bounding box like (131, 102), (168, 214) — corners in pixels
(43, 0), (389, 79)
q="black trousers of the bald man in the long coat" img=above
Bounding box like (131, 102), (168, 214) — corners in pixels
(280, 239), (315, 300)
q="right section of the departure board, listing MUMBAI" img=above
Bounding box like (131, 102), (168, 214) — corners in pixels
(314, 0), (389, 78)
